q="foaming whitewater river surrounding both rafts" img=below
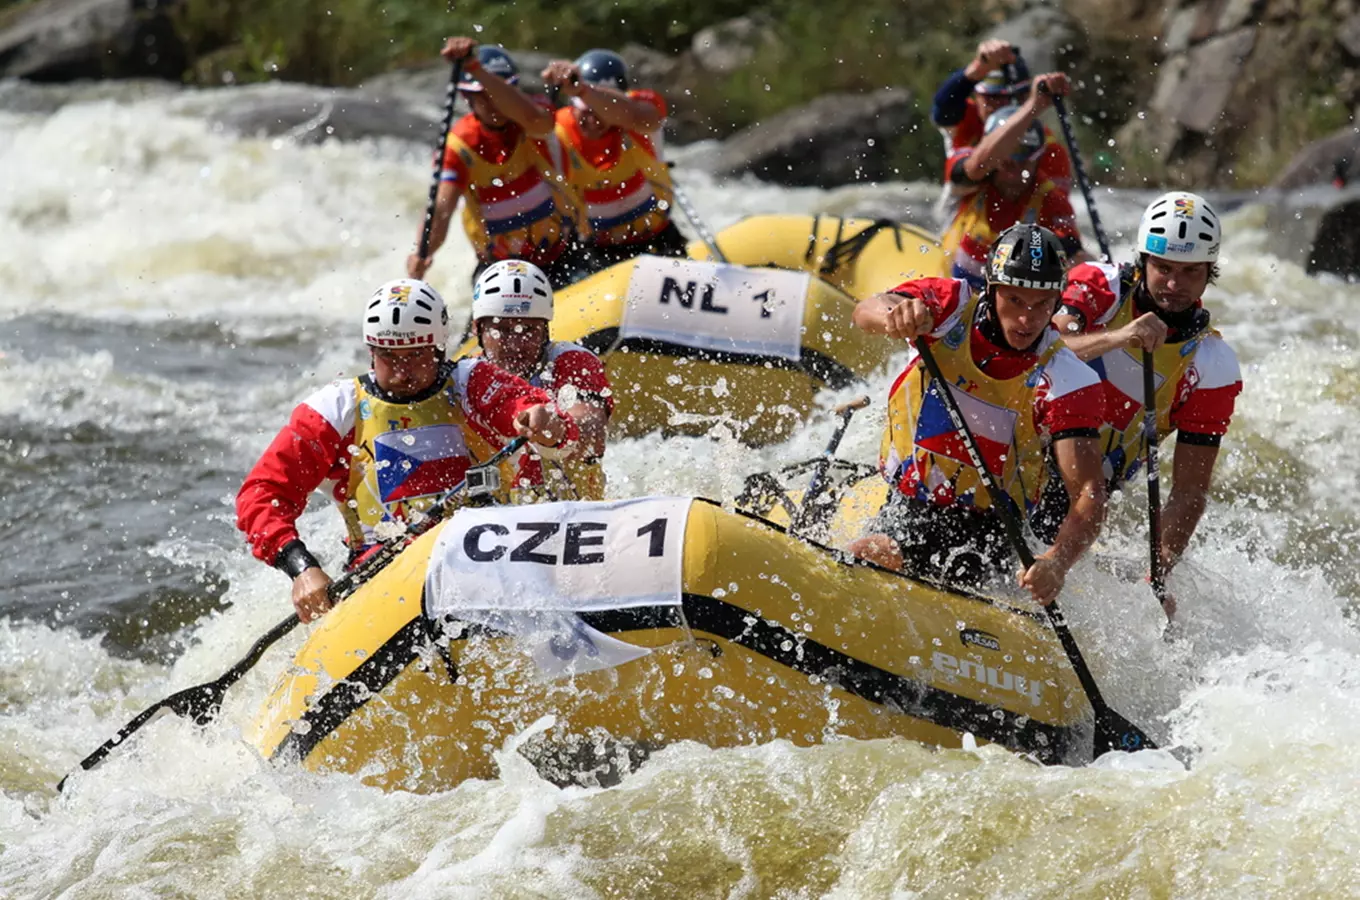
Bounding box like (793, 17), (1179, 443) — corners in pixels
(0, 86), (1360, 897)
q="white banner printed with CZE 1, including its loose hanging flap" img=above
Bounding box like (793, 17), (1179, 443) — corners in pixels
(424, 498), (691, 678)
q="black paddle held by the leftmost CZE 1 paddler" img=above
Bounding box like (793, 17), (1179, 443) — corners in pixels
(57, 438), (526, 793)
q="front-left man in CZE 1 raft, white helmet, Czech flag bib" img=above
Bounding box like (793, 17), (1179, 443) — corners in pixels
(237, 279), (579, 621)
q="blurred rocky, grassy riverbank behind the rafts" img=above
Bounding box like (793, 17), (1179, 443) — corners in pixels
(0, 0), (1360, 273)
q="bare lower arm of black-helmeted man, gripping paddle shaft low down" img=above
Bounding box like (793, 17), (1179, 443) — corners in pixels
(1020, 436), (1107, 605)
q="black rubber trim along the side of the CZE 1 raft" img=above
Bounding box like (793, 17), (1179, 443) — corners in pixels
(271, 594), (1077, 764)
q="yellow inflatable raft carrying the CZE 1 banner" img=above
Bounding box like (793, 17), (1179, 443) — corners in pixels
(249, 498), (1091, 791)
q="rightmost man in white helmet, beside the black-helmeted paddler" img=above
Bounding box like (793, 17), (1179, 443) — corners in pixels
(1053, 190), (1242, 592)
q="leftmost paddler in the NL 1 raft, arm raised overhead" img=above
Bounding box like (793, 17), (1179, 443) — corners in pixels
(407, 38), (585, 287)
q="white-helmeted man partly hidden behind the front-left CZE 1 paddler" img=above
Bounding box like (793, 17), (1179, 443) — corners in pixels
(472, 260), (613, 500)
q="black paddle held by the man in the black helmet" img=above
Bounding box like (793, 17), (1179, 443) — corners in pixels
(913, 337), (1157, 756)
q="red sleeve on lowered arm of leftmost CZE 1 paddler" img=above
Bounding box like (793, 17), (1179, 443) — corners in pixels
(237, 404), (348, 566)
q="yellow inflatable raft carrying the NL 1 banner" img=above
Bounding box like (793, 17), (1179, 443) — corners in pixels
(460, 216), (947, 446)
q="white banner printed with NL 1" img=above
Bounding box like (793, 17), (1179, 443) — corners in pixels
(619, 256), (812, 362)
